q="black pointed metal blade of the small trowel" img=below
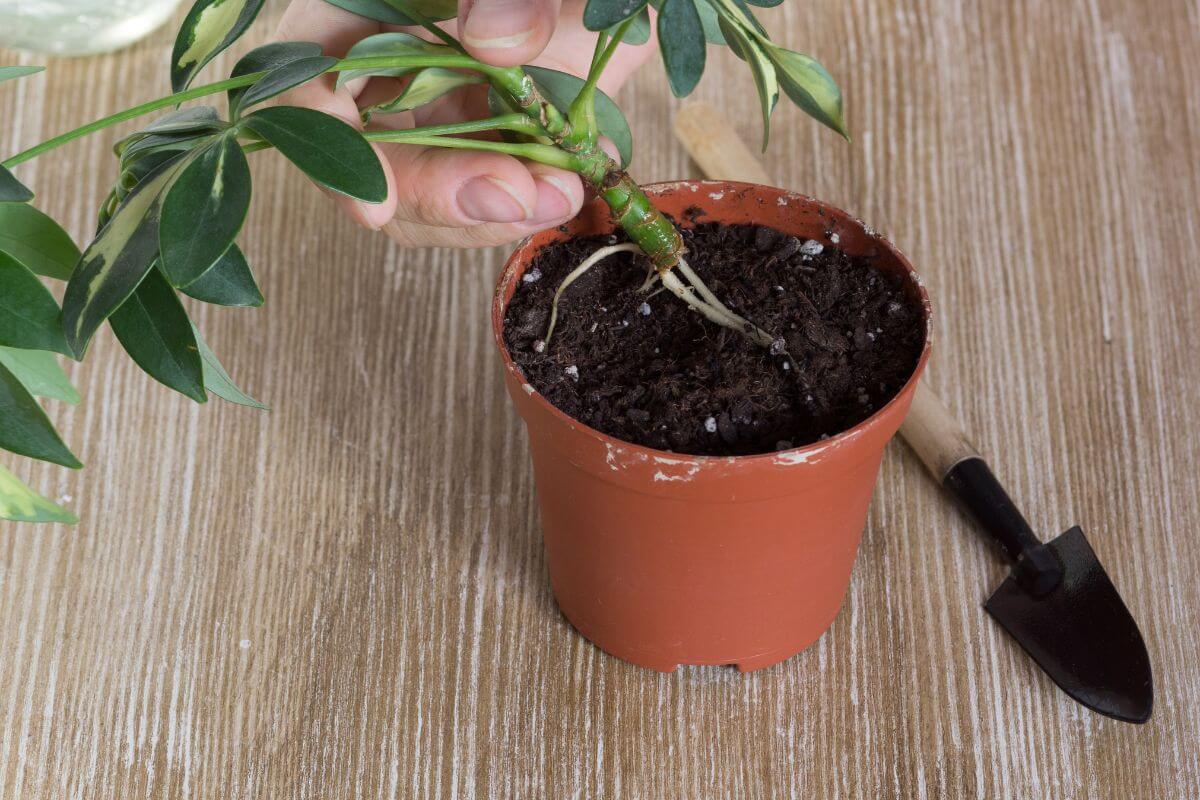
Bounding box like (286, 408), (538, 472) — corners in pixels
(984, 527), (1154, 723)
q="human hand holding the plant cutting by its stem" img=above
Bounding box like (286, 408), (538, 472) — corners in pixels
(278, 0), (656, 247)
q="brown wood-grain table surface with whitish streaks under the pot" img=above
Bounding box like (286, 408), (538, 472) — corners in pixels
(0, 0), (1200, 800)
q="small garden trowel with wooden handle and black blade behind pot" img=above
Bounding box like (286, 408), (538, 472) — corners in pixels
(676, 103), (1154, 723)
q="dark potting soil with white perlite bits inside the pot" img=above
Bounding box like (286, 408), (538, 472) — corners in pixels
(504, 222), (924, 456)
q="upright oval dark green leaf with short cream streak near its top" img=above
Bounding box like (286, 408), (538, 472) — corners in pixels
(158, 134), (251, 287)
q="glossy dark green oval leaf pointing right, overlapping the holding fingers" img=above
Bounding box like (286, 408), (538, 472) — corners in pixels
(242, 106), (388, 203)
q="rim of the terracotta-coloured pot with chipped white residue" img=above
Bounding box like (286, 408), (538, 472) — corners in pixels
(492, 180), (934, 467)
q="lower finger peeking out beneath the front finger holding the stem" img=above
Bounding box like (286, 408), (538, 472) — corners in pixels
(383, 162), (583, 247)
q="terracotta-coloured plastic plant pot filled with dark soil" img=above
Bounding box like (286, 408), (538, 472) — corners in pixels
(492, 181), (930, 672)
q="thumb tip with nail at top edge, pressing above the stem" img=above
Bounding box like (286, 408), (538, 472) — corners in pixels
(458, 0), (562, 67)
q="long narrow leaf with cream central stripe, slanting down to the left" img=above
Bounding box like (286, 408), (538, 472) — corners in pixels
(62, 156), (187, 359)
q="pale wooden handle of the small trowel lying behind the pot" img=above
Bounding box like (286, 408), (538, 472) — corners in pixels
(674, 103), (978, 483)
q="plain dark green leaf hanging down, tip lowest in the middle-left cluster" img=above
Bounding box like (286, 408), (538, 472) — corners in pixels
(108, 270), (209, 403)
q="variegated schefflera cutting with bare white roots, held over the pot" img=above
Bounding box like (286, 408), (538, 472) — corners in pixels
(0, 0), (845, 522)
